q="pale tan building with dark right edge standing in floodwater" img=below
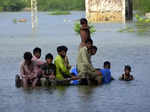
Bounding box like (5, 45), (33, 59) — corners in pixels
(86, 0), (132, 22)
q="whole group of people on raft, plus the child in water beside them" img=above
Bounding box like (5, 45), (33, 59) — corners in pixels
(20, 18), (134, 88)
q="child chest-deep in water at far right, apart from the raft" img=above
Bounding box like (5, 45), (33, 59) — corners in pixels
(119, 65), (134, 81)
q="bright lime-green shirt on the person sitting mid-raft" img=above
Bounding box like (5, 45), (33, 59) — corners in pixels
(54, 55), (70, 80)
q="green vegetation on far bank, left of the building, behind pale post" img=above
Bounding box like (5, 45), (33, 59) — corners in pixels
(0, 0), (85, 11)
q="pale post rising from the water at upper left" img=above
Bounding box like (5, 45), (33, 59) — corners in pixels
(31, 0), (38, 31)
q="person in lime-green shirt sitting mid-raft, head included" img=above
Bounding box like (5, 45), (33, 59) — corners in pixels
(54, 46), (71, 80)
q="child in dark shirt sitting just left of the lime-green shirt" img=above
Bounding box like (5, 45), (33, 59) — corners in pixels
(42, 53), (56, 80)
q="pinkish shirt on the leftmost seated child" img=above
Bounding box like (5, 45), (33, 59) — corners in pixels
(20, 61), (38, 77)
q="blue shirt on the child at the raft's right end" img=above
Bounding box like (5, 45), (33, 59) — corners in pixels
(100, 69), (111, 83)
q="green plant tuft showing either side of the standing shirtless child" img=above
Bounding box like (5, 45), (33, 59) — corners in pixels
(74, 21), (96, 35)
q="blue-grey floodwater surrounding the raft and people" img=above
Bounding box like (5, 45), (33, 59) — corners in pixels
(0, 12), (150, 112)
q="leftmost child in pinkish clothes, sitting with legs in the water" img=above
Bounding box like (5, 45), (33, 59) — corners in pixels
(20, 52), (38, 88)
